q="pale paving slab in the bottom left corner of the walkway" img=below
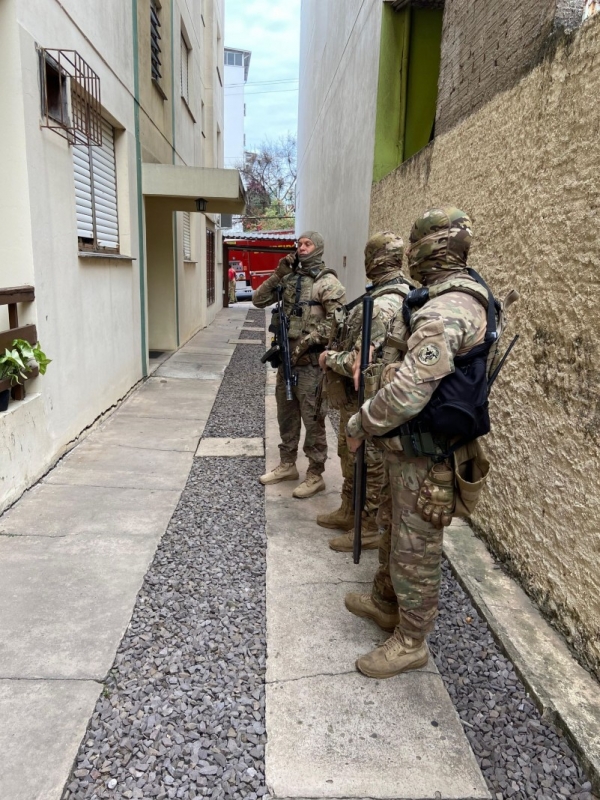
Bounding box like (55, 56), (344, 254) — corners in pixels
(0, 680), (102, 800)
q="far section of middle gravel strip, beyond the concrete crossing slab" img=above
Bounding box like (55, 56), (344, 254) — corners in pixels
(203, 311), (266, 438)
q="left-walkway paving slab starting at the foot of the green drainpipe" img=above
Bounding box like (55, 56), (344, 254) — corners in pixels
(119, 377), (221, 421)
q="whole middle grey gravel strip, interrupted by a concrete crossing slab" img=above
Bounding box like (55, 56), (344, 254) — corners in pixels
(63, 310), (268, 800)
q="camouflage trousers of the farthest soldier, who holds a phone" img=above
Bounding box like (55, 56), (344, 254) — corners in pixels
(275, 364), (327, 475)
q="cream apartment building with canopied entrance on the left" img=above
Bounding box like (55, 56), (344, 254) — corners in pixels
(0, 0), (244, 511)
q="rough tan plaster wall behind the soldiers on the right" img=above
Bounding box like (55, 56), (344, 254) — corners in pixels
(370, 18), (600, 675)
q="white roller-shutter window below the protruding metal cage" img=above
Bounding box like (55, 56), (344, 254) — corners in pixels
(73, 119), (119, 253)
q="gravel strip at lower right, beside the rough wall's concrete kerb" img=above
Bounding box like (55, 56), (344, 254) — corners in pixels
(429, 563), (594, 800)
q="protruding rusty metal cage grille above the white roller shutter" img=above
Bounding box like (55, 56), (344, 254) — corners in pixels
(38, 47), (102, 147)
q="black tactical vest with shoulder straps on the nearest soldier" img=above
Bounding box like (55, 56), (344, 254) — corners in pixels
(384, 269), (501, 455)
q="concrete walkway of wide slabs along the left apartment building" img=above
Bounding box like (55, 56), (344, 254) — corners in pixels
(0, 306), (247, 800)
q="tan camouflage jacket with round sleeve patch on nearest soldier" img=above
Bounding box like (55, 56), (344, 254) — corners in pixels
(347, 276), (486, 439)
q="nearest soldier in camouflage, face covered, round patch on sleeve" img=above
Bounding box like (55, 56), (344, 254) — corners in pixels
(345, 207), (488, 678)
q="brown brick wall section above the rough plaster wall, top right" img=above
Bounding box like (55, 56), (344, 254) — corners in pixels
(436, 0), (556, 134)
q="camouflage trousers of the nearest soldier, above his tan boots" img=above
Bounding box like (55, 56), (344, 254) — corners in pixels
(372, 452), (444, 640)
